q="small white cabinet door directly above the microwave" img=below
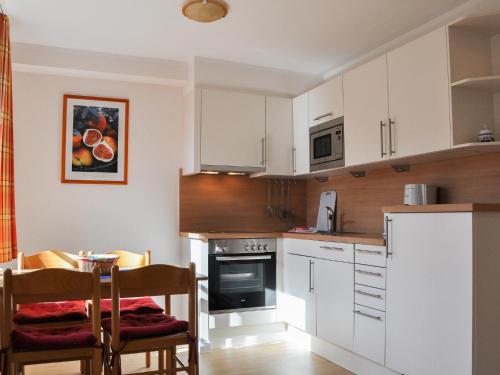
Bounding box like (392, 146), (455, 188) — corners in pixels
(309, 76), (344, 126)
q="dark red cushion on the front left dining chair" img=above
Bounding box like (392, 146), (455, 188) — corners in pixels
(12, 325), (97, 351)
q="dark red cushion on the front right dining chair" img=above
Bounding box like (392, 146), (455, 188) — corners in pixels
(102, 314), (188, 340)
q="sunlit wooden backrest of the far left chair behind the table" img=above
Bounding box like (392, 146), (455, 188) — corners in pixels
(17, 250), (78, 270)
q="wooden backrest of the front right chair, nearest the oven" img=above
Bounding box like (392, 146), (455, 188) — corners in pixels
(111, 263), (197, 350)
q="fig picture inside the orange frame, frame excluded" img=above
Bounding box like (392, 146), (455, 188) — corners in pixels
(71, 105), (119, 173)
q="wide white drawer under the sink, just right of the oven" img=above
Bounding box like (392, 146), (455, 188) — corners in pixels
(284, 238), (354, 263)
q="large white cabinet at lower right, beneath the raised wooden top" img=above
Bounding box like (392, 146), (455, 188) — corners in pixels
(385, 211), (500, 375)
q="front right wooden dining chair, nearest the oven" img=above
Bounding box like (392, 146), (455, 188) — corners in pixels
(103, 263), (198, 375)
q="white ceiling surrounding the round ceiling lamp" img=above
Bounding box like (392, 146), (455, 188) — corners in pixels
(3, 0), (472, 74)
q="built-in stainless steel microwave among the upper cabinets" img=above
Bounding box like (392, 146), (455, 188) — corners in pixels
(309, 117), (345, 172)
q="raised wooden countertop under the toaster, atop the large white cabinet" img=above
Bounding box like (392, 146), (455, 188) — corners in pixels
(382, 203), (500, 213)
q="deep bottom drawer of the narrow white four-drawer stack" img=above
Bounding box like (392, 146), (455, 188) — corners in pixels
(354, 305), (385, 365)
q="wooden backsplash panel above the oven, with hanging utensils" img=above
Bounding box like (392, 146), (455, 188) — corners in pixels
(179, 174), (306, 232)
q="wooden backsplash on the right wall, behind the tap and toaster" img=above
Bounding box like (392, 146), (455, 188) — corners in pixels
(307, 154), (500, 233)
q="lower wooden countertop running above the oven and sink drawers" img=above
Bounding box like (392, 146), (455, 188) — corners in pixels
(179, 232), (385, 246)
